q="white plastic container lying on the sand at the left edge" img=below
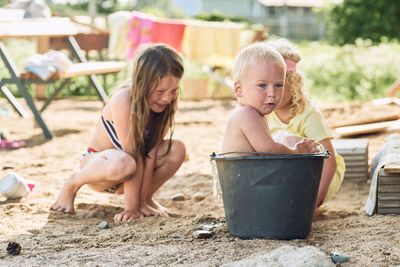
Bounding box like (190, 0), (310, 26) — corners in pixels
(0, 172), (31, 199)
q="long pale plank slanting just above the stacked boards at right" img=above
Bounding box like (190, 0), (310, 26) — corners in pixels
(335, 120), (397, 137)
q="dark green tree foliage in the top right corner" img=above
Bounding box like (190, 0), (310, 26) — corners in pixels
(329, 0), (400, 44)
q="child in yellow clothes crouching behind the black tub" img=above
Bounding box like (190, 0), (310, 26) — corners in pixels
(266, 39), (345, 207)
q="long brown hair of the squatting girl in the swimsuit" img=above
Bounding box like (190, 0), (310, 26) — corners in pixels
(129, 44), (183, 159)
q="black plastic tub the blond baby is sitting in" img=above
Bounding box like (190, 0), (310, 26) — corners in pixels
(210, 151), (329, 240)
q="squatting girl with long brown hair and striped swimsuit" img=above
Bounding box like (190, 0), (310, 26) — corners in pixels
(51, 44), (186, 223)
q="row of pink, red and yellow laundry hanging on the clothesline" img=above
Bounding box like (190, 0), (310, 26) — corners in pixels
(108, 11), (245, 66)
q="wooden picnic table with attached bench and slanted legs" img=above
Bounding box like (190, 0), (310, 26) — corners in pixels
(0, 18), (126, 139)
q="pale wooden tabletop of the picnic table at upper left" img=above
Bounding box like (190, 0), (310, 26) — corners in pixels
(0, 17), (77, 38)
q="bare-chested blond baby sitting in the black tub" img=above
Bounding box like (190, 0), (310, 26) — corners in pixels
(222, 43), (322, 156)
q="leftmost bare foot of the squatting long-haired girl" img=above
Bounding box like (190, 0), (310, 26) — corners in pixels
(50, 178), (79, 214)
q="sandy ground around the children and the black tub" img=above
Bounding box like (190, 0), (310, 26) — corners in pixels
(0, 99), (400, 266)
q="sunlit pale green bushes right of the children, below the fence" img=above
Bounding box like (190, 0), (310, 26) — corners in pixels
(299, 40), (400, 101)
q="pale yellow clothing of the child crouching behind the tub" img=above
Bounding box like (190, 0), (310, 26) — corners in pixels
(267, 104), (345, 203)
